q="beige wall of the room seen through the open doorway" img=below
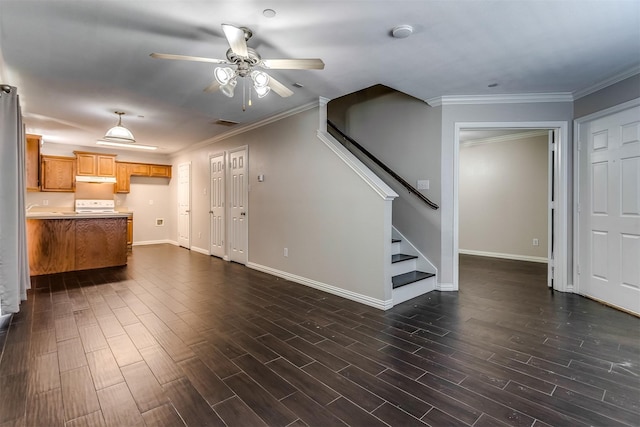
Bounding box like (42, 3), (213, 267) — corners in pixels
(458, 131), (549, 261)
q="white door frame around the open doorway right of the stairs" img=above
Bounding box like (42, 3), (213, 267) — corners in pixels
(452, 122), (572, 292)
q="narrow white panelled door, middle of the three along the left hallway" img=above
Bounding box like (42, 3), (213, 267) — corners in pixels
(209, 153), (225, 258)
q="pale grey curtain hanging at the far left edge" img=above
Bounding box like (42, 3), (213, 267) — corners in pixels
(0, 85), (30, 315)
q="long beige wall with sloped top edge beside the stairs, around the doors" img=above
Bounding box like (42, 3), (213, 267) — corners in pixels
(169, 108), (391, 304)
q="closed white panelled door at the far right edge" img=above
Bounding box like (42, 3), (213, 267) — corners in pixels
(578, 107), (640, 314)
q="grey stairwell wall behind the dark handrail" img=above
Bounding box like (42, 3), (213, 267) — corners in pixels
(329, 91), (441, 274)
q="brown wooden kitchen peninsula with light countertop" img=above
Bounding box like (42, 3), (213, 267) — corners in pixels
(27, 212), (128, 276)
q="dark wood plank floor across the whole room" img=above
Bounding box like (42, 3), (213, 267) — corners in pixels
(0, 245), (640, 427)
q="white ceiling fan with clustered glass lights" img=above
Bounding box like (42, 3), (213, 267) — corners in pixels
(150, 24), (324, 98)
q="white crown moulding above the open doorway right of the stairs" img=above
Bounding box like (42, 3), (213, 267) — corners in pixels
(425, 92), (574, 107)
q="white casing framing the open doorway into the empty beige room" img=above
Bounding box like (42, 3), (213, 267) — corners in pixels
(452, 121), (573, 292)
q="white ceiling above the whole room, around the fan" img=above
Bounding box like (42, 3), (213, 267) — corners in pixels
(0, 0), (640, 154)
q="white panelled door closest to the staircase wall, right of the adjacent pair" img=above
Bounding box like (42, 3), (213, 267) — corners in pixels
(228, 148), (249, 264)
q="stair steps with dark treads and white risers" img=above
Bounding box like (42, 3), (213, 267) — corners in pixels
(391, 232), (436, 305)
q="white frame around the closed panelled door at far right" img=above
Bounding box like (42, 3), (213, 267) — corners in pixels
(572, 98), (640, 295)
